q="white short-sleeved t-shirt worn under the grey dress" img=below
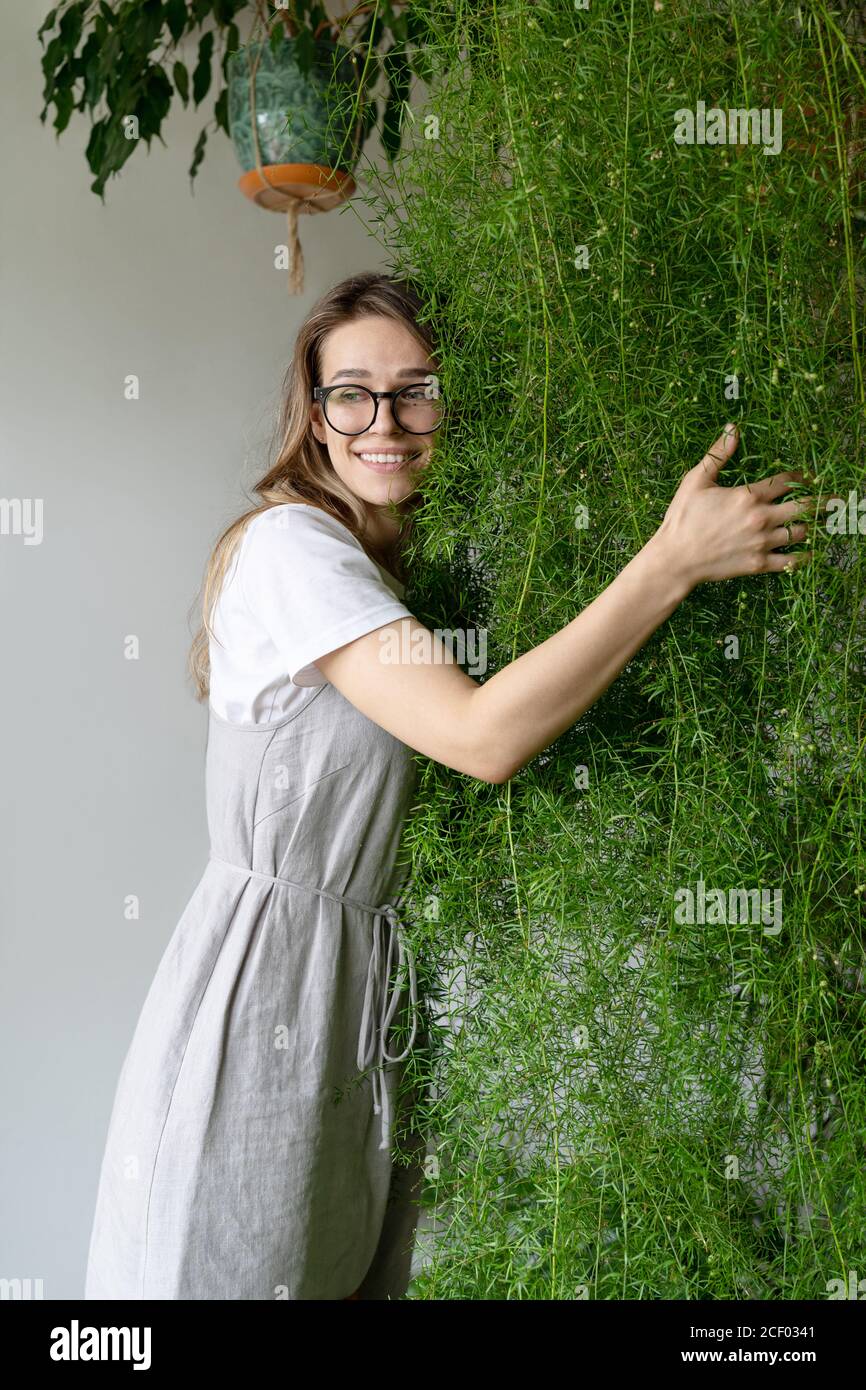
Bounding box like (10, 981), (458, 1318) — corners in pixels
(210, 502), (411, 724)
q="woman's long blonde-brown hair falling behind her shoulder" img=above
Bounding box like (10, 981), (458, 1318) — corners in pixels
(188, 271), (436, 701)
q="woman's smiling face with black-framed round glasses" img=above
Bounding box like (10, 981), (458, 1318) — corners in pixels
(310, 314), (438, 506)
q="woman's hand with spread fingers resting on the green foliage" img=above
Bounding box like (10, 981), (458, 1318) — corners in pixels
(652, 425), (816, 589)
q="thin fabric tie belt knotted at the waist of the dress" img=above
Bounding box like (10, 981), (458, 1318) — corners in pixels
(209, 855), (418, 1148)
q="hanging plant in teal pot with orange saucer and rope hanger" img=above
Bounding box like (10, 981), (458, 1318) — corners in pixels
(38, 0), (430, 291)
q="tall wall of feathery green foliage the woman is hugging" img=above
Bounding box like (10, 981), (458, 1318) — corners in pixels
(368, 0), (866, 1300)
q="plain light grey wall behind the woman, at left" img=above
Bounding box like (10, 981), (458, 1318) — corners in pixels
(0, 0), (414, 1300)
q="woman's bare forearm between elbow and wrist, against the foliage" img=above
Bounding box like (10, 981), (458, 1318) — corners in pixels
(473, 532), (692, 780)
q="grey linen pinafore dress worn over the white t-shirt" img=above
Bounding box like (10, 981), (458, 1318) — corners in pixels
(85, 684), (425, 1300)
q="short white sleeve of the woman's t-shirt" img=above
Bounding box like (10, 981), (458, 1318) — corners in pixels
(238, 502), (411, 685)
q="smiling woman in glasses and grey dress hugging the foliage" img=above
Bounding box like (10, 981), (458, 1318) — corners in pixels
(86, 274), (815, 1300)
